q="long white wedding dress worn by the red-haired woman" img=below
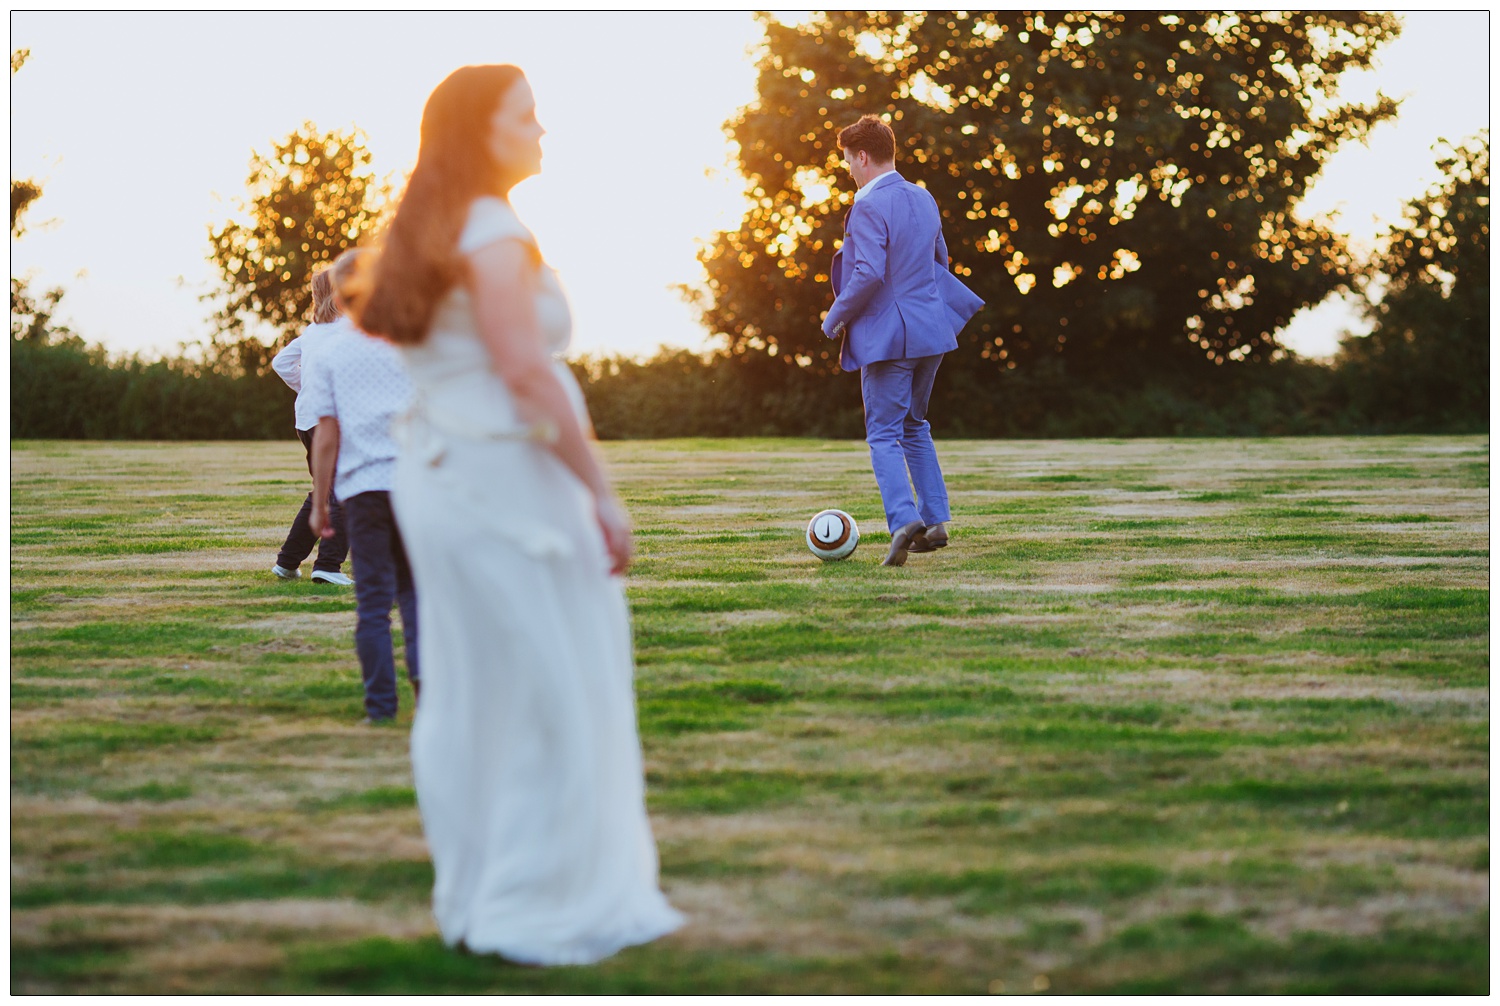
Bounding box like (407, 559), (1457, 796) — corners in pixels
(392, 196), (683, 964)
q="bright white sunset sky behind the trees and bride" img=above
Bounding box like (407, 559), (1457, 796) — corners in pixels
(11, 12), (1490, 364)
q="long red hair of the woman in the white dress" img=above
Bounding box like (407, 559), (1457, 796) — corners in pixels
(339, 64), (524, 345)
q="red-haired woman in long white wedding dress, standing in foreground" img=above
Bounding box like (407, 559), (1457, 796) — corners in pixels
(347, 66), (683, 964)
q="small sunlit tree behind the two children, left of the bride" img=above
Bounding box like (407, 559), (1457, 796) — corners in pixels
(206, 123), (386, 373)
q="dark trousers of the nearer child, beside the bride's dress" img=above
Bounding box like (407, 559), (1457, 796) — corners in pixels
(344, 492), (422, 720)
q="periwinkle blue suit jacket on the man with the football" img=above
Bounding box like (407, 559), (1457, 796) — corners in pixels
(824, 175), (984, 370)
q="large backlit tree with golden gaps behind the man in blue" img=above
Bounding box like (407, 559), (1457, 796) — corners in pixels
(701, 10), (1398, 378)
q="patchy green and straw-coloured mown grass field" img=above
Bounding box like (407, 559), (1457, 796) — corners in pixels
(11, 438), (1490, 993)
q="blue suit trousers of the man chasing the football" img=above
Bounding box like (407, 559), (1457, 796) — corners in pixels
(860, 354), (948, 532)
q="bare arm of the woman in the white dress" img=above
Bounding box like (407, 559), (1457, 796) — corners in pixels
(468, 233), (630, 573)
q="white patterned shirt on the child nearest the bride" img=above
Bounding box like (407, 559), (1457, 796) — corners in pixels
(299, 324), (413, 502)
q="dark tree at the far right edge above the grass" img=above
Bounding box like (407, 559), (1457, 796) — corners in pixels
(1338, 130), (1490, 432)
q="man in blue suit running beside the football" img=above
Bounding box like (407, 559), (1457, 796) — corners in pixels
(824, 115), (984, 565)
